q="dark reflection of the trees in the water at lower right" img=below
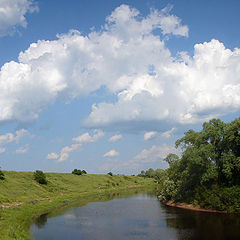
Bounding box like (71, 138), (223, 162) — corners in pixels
(166, 204), (240, 240)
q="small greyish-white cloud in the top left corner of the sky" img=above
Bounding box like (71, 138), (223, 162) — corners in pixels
(0, 0), (38, 36)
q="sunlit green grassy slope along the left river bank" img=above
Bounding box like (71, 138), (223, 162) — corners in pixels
(0, 172), (154, 240)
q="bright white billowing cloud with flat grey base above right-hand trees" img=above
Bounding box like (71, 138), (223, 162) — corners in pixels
(86, 40), (240, 127)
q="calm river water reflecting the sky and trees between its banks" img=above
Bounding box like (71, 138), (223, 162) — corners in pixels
(30, 194), (240, 240)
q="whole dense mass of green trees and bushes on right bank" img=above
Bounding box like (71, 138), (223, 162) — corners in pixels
(160, 119), (240, 211)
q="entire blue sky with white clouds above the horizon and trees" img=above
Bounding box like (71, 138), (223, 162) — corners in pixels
(0, 0), (240, 174)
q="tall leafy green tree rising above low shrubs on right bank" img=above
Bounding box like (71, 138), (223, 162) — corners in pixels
(160, 118), (240, 201)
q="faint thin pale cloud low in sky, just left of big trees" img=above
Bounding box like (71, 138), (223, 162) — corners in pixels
(132, 144), (181, 163)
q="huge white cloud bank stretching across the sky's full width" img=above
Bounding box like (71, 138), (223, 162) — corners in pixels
(0, 5), (240, 131)
